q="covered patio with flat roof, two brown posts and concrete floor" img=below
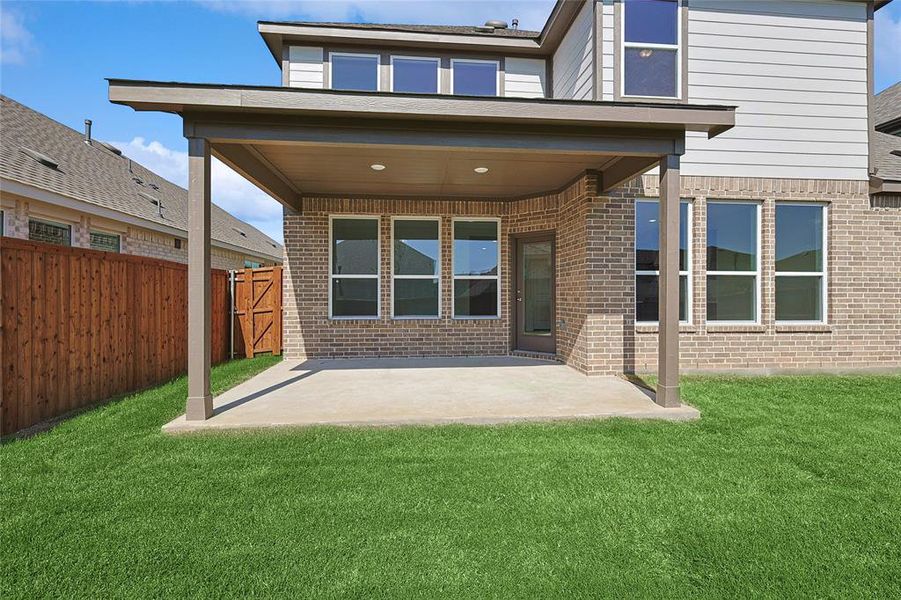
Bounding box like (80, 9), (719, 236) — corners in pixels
(109, 80), (735, 424)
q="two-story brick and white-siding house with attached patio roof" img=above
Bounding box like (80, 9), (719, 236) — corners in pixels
(110, 0), (901, 418)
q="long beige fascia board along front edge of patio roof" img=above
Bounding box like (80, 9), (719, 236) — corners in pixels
(109, 80), (735, 133)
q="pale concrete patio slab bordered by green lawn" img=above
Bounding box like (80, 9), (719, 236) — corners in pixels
(163, 356), (700, 433)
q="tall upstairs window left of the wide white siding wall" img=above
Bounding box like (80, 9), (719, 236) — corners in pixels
(620, 0), (682, 98)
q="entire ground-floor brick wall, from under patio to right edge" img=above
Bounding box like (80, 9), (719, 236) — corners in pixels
(284, 174), (901, 374)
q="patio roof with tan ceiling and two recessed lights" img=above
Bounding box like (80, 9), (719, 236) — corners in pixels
(109, 79), (734, 209)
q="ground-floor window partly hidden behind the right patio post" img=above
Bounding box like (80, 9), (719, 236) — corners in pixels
(635, 200), (691, 323)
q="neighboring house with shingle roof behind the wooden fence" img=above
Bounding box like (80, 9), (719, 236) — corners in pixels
(0, 96), (282, 269)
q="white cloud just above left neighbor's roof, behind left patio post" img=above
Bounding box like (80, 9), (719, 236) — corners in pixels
(110, 137), (282, 242)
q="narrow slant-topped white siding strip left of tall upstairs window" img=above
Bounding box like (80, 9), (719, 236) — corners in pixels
(554, 1), (594, 100)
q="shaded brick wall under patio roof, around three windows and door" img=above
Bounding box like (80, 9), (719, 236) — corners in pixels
(284, 173), (593, 360)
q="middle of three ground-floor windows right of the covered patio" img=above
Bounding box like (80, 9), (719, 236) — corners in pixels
(707, 202), (760, 323)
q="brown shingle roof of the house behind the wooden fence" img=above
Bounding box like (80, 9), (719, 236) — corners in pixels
(0, 95), (282, 262)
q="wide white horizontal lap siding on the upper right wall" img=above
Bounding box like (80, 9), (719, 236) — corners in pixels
(682, 0), (868, 180)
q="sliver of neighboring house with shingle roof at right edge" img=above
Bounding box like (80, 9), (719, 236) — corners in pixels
(870, 83), (901, 208)
